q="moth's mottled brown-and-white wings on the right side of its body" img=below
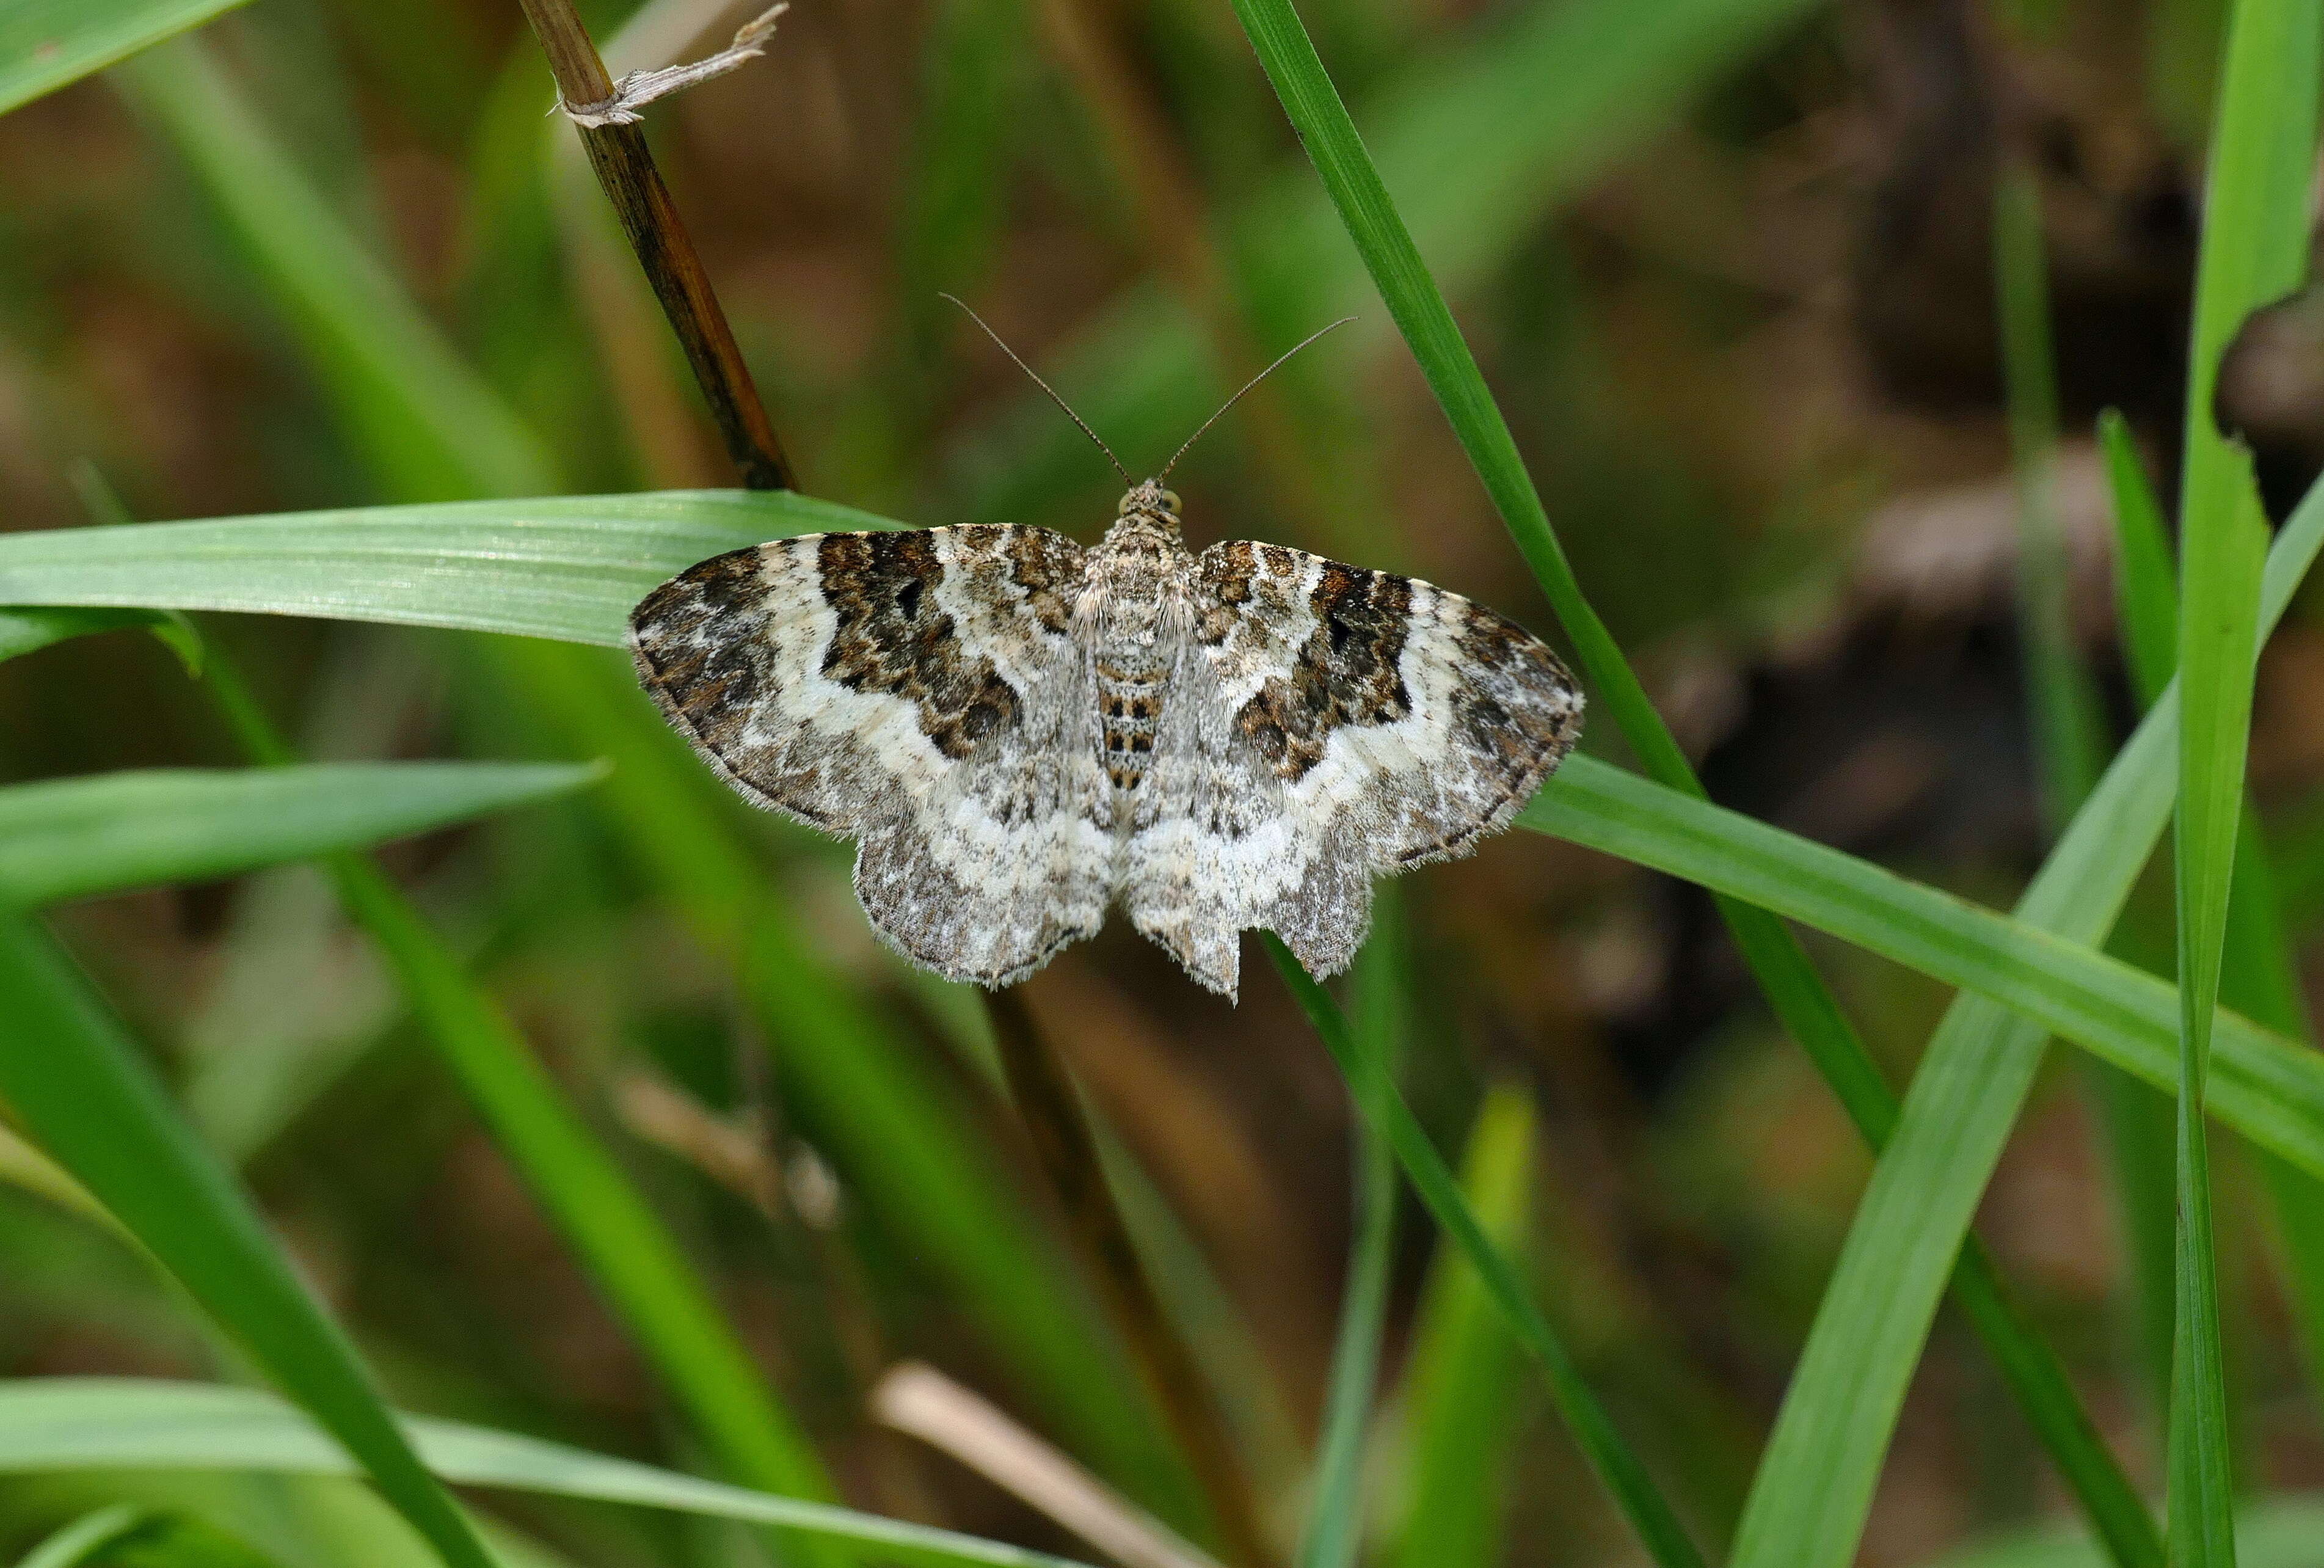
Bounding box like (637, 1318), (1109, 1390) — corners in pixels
(1120, 541), (1583, 992)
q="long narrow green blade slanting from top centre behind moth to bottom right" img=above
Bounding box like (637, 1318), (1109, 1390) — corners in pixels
(1234, 0), (2157, 1563)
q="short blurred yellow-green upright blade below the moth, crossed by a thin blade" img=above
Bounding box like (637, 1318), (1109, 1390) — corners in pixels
(1394, 1087), (1534, 1568)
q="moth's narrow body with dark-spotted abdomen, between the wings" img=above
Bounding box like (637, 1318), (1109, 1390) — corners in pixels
(1080, 481), (1195, 792)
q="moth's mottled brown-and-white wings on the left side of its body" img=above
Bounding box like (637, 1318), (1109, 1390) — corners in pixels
(630, 525), (1111, 985)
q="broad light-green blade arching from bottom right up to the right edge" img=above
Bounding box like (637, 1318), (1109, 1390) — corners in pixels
(1734, 467), (2324, 1568)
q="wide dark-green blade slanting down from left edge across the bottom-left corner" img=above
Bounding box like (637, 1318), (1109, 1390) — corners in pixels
(0, 911), (490, 1568)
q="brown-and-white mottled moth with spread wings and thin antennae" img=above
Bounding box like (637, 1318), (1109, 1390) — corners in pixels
(630, 307), (1583, 996)
